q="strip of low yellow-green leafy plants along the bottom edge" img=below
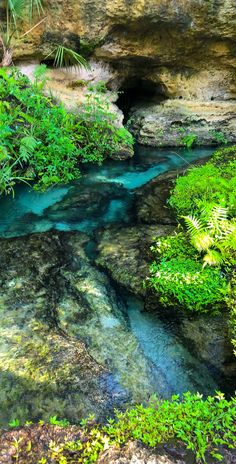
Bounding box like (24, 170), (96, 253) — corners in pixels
(39, 392), (236, 464)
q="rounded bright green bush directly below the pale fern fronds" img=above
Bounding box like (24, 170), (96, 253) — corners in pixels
(147, 232), (228, 312)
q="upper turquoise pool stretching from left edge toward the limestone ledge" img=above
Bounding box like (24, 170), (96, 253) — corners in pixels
(0, 148), (212, 237)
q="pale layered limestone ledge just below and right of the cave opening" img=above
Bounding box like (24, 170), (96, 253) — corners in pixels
(132, 99), (236, 147)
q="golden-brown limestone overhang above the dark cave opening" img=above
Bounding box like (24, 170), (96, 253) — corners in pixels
(12, 0), (236, 96)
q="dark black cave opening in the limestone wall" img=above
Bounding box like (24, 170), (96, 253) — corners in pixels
(116, 77), (166, 123)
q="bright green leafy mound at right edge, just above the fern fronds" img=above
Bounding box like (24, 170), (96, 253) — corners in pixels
(169, 154), (236, 216)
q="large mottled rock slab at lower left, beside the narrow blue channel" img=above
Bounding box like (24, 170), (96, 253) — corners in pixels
(0, 232), (157, 424)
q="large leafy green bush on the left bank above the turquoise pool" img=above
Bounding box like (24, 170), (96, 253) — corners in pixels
(0, 69), (133, 193)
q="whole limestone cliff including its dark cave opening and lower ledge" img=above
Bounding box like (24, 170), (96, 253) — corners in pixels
(3, 0), (236, 146)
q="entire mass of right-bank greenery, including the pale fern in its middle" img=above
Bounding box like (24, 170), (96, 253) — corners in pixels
(148, 147), (236, 312)
